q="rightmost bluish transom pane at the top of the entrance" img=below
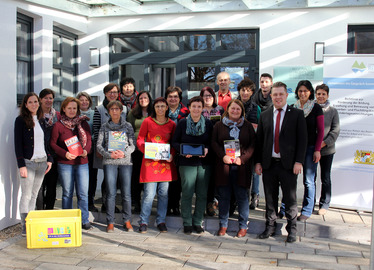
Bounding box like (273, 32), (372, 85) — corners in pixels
(221, 33), (256, 50)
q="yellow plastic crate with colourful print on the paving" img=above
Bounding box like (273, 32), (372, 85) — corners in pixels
(26, 209), (82, 248)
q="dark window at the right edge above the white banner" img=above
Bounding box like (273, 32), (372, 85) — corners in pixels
(347, 25), (374, 54)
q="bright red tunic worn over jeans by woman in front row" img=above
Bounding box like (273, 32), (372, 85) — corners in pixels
(136, 117), (178, 183)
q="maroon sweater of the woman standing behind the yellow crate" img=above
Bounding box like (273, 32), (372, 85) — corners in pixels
(50, 121), (91, 165)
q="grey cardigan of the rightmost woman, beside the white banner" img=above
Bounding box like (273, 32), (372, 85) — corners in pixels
(321, 106), (340, 156)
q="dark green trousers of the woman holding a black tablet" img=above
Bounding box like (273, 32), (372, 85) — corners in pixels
(179, 166), (210, 226)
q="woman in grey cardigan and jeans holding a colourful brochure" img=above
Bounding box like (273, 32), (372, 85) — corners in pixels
(96, 100), (135, 233)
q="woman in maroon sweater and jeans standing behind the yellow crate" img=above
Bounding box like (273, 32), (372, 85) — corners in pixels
(50, 97), (91, 230)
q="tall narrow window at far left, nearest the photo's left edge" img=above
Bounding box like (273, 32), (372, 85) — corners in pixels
(17, 13), (33, 104)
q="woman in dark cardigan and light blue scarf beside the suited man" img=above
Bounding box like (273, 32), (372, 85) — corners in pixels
(212, 99), (256, 237)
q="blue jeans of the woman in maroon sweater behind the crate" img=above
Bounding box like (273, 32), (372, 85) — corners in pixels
(58, 163), (89, 224)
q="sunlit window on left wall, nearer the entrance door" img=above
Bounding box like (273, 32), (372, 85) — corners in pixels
(53, 27), (78, 97)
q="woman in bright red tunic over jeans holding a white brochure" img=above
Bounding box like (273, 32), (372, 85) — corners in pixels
(137, 97), (178, 233)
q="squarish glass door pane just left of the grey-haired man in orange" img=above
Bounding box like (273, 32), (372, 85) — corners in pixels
(188, 64), (216, 92)
